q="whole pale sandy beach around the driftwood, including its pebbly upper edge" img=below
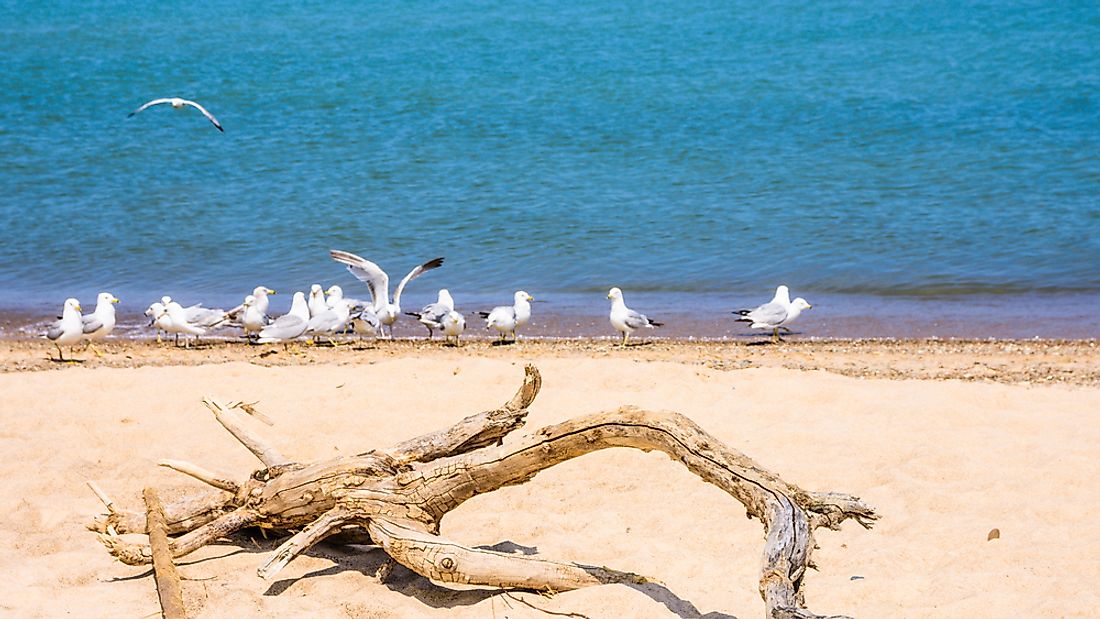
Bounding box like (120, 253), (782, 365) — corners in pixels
(0, 340), (1100, 618)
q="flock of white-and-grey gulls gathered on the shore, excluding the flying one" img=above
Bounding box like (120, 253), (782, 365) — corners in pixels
(38, 250), (812, 361)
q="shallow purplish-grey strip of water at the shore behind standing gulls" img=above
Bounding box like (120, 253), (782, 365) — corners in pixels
(0, 292), (1100, 341)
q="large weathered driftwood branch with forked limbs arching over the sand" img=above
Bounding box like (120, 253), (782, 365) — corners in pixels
(90, 366), (877, 618)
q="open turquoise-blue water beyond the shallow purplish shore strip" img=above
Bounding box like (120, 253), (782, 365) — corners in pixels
(0, 0), (1100, 334)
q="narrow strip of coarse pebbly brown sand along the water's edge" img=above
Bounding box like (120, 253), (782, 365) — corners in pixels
(0, 338), (1100, 387)
